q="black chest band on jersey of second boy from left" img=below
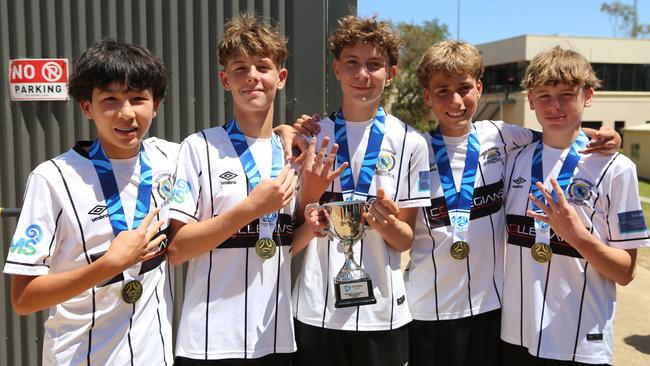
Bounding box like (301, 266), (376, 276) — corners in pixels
(216, 213), (293, 249)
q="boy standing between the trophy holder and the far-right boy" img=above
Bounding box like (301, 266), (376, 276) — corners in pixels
(405, 41), (620, 365)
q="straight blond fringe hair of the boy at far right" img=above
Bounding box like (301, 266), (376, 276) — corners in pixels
(521, 46), (600, 90)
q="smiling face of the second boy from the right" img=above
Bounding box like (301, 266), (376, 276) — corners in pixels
(424, 72), (483, 137)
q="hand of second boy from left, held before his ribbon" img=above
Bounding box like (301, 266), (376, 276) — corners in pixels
(247, 164), (298, 216)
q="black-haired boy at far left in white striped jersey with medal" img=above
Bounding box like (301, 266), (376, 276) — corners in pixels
(4, 40), (178, 366)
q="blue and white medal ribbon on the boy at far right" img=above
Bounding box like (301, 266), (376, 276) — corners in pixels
(530, 130), (589, 245)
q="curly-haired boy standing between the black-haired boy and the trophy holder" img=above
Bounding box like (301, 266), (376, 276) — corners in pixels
(165, 14), (337, 365)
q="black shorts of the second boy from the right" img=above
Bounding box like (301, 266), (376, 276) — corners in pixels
(409, 309), (501, 366)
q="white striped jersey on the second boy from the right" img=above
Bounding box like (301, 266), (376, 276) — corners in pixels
(404, 121), (533, 320)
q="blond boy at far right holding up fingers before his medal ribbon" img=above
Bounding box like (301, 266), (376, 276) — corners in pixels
(501, 47), (650, 365)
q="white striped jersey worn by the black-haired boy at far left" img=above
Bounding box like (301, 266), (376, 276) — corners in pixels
(4, 138), (178, 366)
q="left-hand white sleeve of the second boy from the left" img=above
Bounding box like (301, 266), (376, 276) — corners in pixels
(169, 136), (203, 223)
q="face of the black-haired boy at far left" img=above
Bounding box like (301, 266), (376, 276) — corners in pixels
(79, 82), (160, 159)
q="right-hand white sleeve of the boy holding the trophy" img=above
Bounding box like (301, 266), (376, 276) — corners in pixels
(397, 130), (431, 208)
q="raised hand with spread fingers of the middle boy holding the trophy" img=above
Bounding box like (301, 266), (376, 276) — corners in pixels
(300, 137), (348, 203)
